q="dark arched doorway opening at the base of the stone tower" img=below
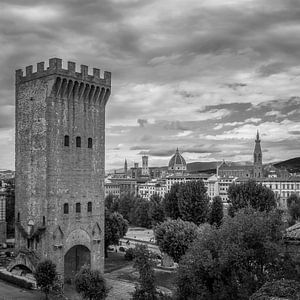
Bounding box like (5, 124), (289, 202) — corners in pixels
(64, 245), (91, 283)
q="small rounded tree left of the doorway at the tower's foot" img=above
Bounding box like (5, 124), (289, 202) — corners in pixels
(34, 259), (57, 299)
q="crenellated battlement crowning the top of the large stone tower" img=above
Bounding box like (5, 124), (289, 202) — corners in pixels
(16, 58), (111, 87)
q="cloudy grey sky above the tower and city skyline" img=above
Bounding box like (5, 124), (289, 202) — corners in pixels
(0, 0), (300, 169)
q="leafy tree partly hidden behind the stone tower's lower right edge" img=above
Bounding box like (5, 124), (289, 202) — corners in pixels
(104, 209), (128, 257)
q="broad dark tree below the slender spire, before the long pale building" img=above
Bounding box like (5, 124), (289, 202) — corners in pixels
(227, 180), (276, 214)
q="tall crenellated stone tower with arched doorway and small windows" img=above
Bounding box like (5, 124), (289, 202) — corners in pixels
(9, 58), (111, 279)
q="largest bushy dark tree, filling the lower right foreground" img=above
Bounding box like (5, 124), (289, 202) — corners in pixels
(177, 208), (297, 300)
